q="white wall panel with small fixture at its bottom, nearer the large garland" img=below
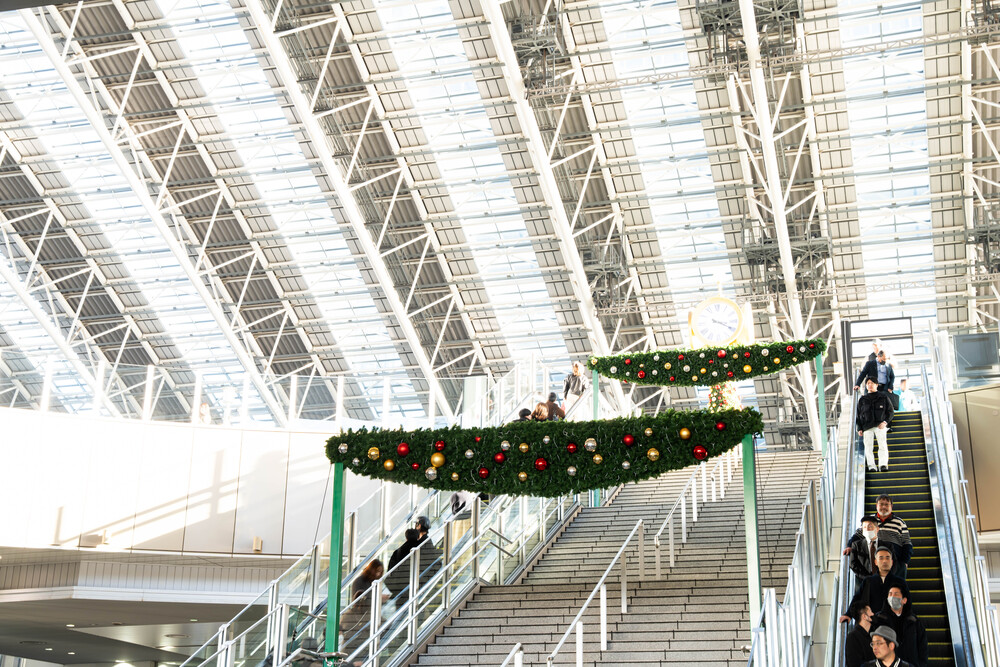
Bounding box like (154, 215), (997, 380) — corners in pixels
(233, 431), (288, 554)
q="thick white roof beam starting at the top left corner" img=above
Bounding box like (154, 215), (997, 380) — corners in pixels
(20, 9), (286, 426)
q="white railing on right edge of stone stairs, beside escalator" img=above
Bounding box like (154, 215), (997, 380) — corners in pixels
(747, 426), (837, 667)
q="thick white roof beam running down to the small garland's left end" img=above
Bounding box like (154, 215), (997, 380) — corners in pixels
(480, 2), (630, 410)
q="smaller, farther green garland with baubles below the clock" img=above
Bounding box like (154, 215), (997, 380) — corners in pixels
(590, 338), (826, 387)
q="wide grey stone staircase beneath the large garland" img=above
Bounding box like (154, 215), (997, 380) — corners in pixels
(417, 452), (820, 667)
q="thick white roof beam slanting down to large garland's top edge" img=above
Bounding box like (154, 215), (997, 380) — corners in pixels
(246, 0), (455, 421)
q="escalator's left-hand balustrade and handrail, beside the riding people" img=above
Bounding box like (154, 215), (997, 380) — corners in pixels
(826, 393), (865, 667)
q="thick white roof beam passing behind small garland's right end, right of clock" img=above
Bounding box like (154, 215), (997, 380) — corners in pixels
(739, 0), (823, 449)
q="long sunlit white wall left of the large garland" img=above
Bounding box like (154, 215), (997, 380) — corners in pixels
(0, 408), (378, 556)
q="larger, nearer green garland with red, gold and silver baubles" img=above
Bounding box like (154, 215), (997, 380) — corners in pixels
(326, 408), (764, 497)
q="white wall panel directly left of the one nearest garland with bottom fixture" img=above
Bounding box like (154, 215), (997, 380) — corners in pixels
(184, 428), (242, 553)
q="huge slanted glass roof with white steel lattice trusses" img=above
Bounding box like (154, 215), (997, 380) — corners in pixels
(0, 0), (1000, 438)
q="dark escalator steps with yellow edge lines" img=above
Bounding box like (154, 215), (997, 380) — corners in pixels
(865, 412), (955, 666)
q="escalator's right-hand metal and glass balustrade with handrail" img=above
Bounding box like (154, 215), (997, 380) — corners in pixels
(921, 352), (1000, 667)
